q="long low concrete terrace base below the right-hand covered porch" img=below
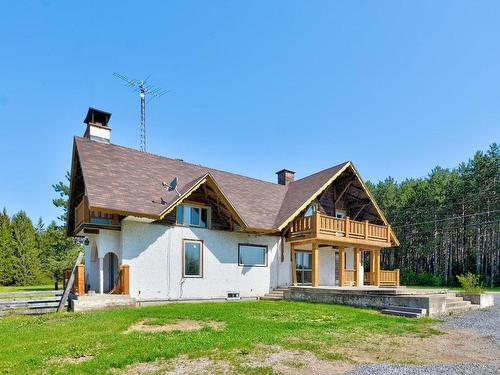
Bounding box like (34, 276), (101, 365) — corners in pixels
(284, 286), (447, 317)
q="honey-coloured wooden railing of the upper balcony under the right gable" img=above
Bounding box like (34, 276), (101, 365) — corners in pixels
(289, 212), (391, 242)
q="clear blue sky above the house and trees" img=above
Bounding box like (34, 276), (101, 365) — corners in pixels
(0, 0), (500, 221)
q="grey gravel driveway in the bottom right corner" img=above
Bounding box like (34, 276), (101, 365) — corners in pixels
(348, 293), (500, 375)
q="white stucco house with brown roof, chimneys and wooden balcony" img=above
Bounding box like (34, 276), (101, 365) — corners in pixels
(67, 108), (399, 301)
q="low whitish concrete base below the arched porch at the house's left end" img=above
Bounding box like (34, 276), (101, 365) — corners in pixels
(69, 294), (136, 312)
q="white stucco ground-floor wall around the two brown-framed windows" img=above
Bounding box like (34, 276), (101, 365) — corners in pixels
(119, 219), (291, 300)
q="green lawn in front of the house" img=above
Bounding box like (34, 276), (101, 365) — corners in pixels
(0, 301), (436, 374)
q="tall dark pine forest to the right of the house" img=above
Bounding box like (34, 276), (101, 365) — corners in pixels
(367, 143), (500, 286)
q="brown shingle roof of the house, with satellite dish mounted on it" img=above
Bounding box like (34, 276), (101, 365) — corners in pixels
(75, 137), (352, 229)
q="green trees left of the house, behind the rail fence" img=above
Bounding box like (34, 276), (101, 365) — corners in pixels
(0, 175), (81, 289)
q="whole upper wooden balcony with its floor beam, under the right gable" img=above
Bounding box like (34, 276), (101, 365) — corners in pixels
(287, 212), (392, 248)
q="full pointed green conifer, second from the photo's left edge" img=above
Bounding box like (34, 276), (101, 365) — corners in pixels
(11, 211), (41, 285)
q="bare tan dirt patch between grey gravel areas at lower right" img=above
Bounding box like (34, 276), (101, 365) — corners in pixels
(335, 329), (500, 364)
